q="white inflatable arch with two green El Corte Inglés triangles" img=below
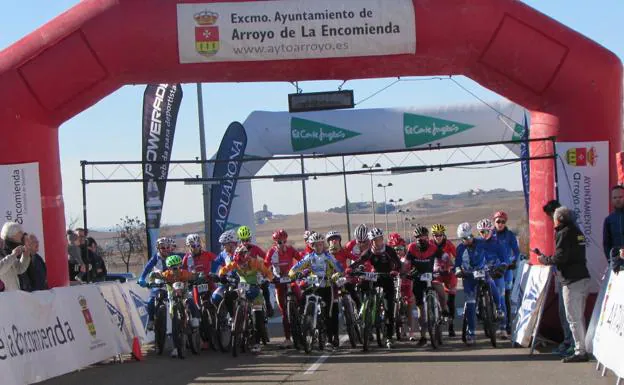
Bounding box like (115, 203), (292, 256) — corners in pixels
(210, 102), (525, 236)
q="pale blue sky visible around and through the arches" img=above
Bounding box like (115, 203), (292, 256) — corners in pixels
(0, 0), (624, 228)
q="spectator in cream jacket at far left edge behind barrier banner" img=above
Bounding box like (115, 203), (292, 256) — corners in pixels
(0, 222), (32, 291)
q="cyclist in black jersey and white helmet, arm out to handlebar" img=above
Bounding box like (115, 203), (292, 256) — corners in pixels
(351, 227), (401, 349)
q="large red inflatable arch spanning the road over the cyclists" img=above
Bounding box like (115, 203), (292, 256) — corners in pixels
(0, 0), (622, 286)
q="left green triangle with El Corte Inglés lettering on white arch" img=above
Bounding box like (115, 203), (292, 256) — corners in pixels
(290, 118), (361, 151)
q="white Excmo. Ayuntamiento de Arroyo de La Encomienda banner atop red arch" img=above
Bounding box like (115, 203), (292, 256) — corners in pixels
(177, 0), (416, 63)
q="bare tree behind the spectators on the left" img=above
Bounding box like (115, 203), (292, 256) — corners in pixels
(112, 216), (147, 272)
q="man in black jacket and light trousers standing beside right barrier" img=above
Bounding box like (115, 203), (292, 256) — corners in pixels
(534, 206), (589, 363)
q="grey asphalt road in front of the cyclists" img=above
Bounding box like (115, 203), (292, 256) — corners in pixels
(42, 323), (615, 385)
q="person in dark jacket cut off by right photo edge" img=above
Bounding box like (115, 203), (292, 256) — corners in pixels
(602, 185), (624, 271)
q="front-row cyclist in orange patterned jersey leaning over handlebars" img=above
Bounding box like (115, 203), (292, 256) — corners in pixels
(218, 244), (274, 353)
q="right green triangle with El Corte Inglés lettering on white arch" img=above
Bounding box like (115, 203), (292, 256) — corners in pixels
(403, 113), (474, 148)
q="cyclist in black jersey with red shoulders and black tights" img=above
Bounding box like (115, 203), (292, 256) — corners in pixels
(407, 224), (450, 346)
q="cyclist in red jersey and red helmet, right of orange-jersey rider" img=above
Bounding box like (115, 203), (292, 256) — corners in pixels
(264, 229), (301, 348)
